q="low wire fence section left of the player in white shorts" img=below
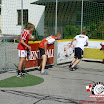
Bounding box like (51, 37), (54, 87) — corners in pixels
(0, 36), (20, 73)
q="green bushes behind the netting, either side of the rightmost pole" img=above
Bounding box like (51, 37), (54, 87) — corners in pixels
(63, 21), (104, 39)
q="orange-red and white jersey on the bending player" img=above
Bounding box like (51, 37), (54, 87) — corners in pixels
(39, 36), (55, 49)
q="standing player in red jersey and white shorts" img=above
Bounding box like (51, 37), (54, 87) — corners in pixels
(17, 23), (35, 78)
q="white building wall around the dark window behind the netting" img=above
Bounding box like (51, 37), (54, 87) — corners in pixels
(1, 0), (45, 35)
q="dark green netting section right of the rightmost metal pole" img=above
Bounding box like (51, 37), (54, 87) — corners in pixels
(83, 1), (104, 39)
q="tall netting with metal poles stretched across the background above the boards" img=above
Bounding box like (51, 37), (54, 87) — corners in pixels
(0, 0), (104, 40)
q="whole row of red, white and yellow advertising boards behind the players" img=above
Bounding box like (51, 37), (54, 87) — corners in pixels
(26, 39), (104, 68)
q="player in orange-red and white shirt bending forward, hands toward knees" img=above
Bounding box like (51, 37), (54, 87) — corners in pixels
(39, 33), (61, 75)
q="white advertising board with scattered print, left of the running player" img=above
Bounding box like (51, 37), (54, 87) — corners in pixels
(57, 40), (75, 64)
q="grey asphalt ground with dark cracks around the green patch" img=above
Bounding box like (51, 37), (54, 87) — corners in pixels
(0, 61), (104, 104)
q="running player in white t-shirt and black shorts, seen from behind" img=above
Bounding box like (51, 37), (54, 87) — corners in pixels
(69, 29), (88, 71)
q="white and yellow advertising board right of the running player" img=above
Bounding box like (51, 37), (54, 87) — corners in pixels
(84, 39), (104, 61)
